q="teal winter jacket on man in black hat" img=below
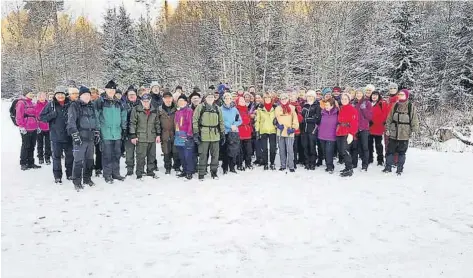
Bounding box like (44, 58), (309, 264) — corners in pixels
(95, 98), (125, 140)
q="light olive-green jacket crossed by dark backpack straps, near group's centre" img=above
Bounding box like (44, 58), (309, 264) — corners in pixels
(192, 103), (225, 142)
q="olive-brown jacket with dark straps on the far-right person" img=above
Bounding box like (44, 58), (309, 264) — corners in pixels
(386, 101), (419, 140)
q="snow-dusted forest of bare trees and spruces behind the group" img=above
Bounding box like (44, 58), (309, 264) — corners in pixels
(2, 0), (473, 146)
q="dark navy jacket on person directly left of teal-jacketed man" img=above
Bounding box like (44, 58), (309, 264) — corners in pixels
(67, 100), (100, 141)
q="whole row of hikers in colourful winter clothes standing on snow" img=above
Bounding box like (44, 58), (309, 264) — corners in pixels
(10, 81), (419, 191)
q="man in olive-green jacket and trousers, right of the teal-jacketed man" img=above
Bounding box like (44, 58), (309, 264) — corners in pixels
(129, 94), (160, 179)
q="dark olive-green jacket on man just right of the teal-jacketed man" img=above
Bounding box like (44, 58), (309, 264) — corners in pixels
(130, 105), (161, 143)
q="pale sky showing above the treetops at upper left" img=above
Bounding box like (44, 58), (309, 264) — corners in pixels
(2, 0), (178, 25)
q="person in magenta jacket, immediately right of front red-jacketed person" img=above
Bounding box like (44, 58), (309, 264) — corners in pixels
(352, 89), (373, 172)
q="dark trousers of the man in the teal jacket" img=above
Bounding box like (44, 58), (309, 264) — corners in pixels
(102, 139), (122, 178)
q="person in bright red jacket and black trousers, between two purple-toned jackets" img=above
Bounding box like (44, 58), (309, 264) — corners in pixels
(336, 93), (358, 177)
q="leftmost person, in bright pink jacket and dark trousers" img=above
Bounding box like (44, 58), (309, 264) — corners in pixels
(16, 89), (41, 171)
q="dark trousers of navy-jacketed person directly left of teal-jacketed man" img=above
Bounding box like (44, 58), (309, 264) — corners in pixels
(72, 141), (94, 184)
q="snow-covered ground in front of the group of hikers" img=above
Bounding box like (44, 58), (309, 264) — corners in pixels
(1, 102), (473, 278)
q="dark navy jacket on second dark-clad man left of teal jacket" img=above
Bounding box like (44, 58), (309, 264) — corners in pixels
(39, 98), (72, 143)
